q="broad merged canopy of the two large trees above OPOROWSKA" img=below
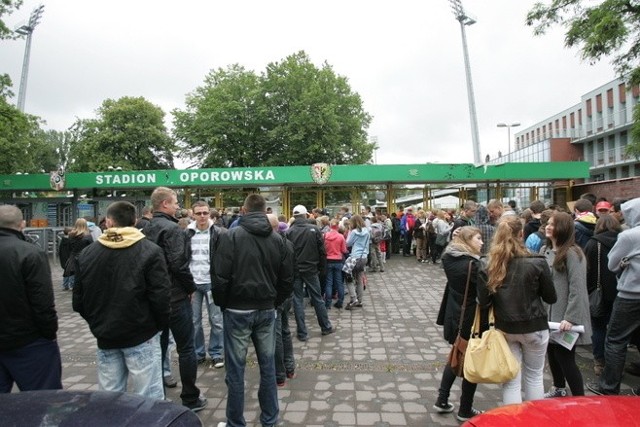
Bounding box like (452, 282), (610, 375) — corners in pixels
(173, 52), (373, 167)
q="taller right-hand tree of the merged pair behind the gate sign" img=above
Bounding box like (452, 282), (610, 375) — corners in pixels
(263, 52), (374, 165)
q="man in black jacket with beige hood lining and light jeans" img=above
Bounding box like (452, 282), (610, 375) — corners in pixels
(73, 202), (170, 400)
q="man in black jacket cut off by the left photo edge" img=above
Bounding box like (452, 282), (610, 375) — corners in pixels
(0, 205), (62, 393)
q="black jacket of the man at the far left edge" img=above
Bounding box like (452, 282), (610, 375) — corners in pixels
(0, 228), (58, 351)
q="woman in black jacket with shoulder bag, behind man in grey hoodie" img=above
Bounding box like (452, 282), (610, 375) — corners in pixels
(584, 215), (622, 375)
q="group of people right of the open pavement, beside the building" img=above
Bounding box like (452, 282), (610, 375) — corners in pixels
(432, 194), (640, 421)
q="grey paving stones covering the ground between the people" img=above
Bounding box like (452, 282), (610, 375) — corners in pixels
(52, 255), (640, 427)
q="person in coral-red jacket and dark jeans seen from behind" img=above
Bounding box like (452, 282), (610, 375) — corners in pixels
(324, 219), (347, 310)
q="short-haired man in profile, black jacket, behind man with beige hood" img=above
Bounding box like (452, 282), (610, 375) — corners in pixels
(144, 187), (207, 412)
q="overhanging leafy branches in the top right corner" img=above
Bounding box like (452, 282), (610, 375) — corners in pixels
(526, 0), (640, 158)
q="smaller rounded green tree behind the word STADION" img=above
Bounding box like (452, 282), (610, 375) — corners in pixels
(67, 97), (176, 172)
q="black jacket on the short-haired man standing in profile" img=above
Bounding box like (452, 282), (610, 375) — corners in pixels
(144, 212), (196, 302)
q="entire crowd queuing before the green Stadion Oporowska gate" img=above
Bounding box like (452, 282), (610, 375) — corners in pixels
(0, 187), (640, 427)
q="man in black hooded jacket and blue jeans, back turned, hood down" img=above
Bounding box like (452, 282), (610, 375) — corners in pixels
(212, 194), (293, 426)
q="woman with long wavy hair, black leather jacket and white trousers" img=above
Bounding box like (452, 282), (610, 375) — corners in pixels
(478, 216), (556, 405)
